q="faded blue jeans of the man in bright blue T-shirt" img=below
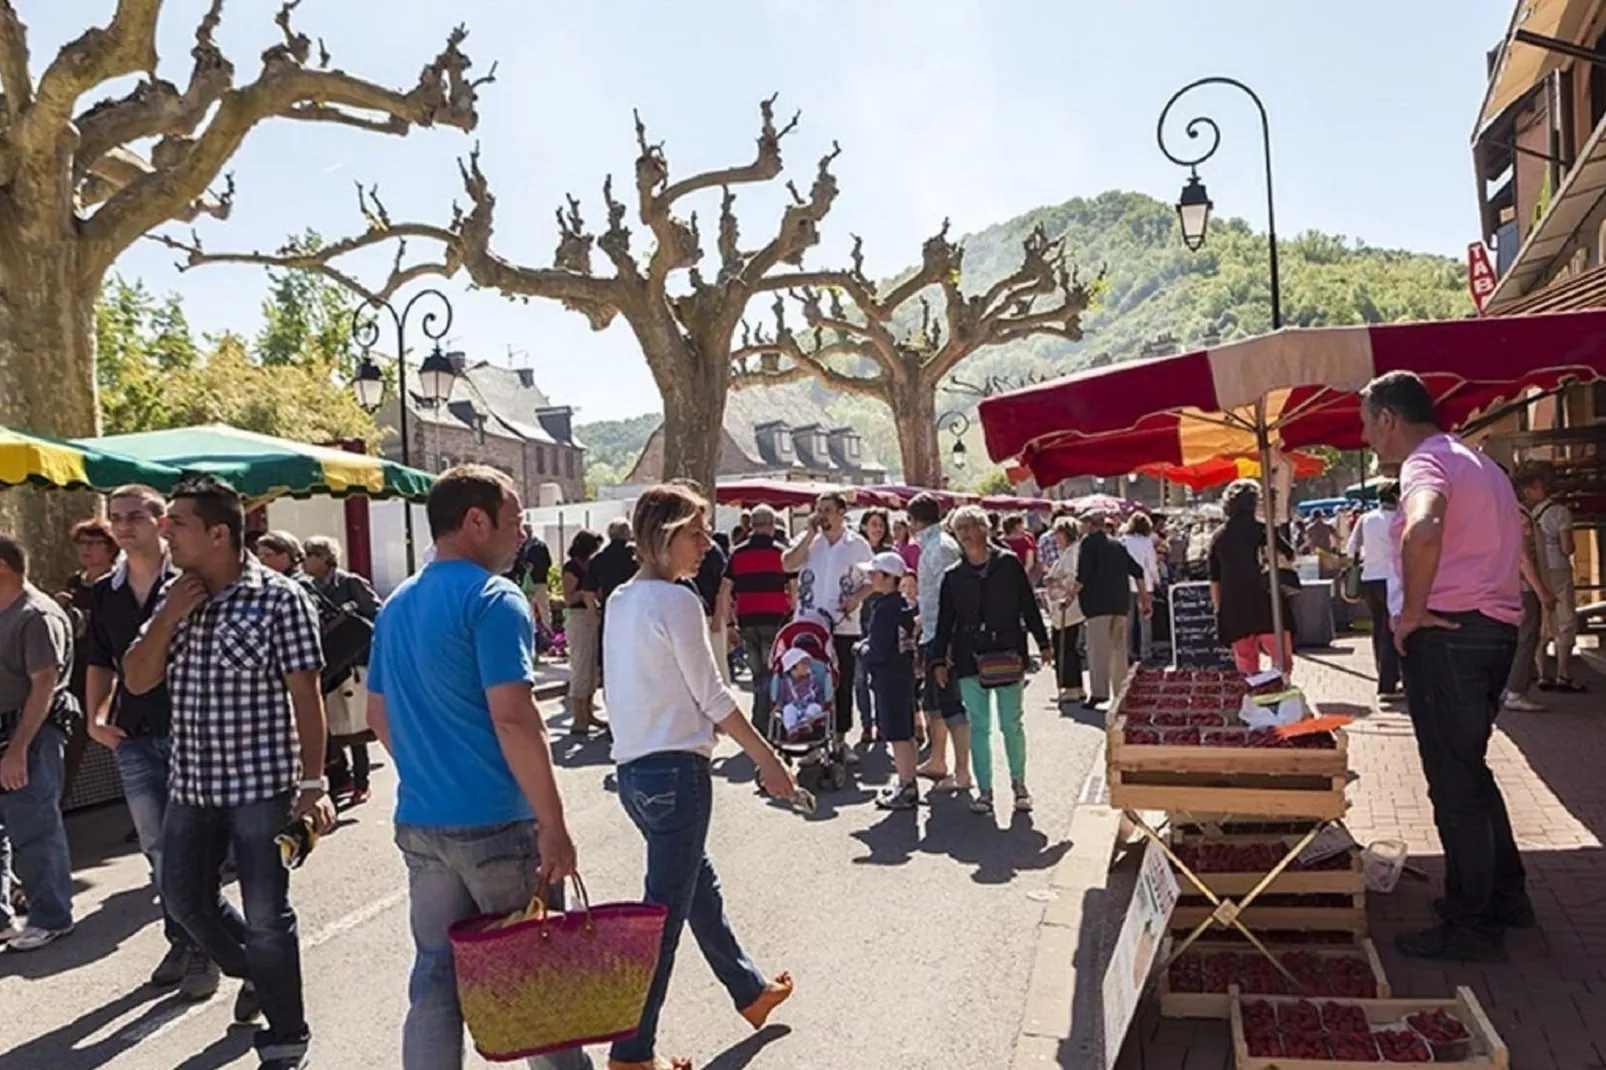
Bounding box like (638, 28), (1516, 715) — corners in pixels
(395, 821), (591, 1070)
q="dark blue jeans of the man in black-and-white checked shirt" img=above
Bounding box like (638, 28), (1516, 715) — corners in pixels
(161, 792), (310, 1060)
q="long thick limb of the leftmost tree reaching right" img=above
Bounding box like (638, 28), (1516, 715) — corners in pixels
(84, 20), (483, 273)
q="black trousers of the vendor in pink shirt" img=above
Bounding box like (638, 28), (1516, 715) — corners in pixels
(1402, 612), (1527, 937)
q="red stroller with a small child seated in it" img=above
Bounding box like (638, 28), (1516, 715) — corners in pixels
(769, 620), (848, 789)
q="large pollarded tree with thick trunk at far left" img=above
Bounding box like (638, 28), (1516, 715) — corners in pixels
(0, 0), (488, 565)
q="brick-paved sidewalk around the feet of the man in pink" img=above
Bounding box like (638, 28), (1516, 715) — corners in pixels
(1121, 636), (1606, 1070)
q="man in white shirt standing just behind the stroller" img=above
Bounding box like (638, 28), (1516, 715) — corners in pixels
(782, 490), (874, 739)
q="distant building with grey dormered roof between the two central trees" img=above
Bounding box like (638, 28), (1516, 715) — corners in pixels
(625, 384), (887, 487)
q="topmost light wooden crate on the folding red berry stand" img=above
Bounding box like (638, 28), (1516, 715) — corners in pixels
(1105, 672), (1349, 819)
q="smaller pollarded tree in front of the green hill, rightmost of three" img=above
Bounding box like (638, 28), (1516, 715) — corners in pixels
(731, 220), (1090, 487)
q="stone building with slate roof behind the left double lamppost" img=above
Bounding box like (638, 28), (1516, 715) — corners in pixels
(376, 353), (586, 506)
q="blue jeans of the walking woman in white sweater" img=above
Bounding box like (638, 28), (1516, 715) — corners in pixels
(612, 750), (766, 1062)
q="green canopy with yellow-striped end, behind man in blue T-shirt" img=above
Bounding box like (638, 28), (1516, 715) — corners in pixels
(79, 424), (435, 501)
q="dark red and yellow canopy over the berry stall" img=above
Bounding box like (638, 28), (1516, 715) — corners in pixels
(980, 310), (1606, 485)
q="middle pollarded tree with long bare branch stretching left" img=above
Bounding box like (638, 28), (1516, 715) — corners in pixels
(156, 96), (842, 487)
